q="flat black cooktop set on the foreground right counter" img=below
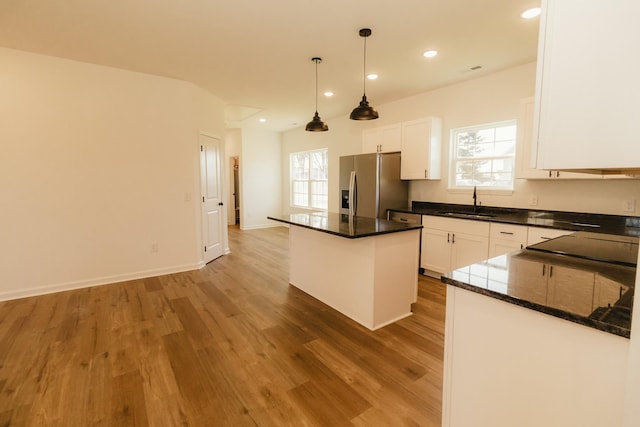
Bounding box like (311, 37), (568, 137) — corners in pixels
(527, 231), (638, 267)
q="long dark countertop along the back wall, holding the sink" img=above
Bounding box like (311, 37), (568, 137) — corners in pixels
(393, 202), (640, 236)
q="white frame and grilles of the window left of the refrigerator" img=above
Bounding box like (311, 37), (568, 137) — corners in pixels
(289, 148), (329, 212)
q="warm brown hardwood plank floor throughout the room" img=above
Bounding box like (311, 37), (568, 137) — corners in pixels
(0, 227), (445, 427)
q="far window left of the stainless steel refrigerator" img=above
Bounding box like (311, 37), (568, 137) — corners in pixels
(289, 148), (329, 210)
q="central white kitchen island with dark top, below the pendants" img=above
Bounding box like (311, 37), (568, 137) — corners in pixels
(268, 212), (422, 330)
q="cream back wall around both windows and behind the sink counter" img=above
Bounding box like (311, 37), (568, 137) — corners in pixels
(282, 63), (640, 215)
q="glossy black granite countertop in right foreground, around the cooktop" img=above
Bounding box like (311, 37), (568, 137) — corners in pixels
(441, 242), (636, 338)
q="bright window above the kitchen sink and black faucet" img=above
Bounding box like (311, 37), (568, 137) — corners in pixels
(449, 120), (516, 190)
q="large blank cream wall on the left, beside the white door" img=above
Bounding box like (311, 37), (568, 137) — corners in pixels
(0, 48), (224, 299)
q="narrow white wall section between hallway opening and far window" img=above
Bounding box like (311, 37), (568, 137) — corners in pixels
(240, 129), (282, 230)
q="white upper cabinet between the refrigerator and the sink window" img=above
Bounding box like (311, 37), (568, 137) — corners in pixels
(400, 117), (442, 179)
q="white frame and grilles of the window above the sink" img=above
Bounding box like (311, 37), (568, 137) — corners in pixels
(447, 119), (518, 193)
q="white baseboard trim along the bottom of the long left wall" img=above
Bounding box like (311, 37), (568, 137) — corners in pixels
(0, 263), (202, 301)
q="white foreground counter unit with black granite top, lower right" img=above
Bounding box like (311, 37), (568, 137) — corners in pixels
(441, 233), (637, 427)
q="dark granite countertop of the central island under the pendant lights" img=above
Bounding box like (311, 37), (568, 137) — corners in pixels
(267, 212), (422, 239)
